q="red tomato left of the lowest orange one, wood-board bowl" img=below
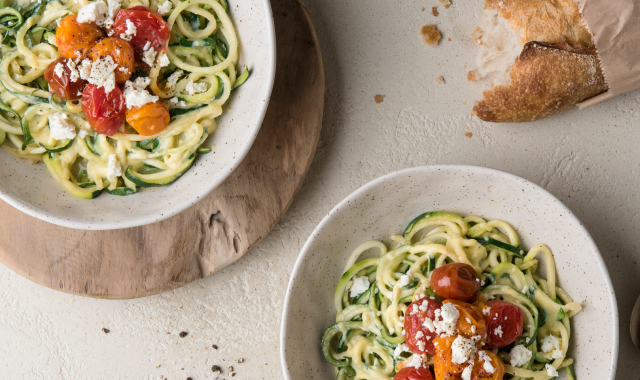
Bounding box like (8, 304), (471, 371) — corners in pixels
(82, 84), (126, 136)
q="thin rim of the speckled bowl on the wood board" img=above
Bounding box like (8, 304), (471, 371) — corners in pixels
(0, 0), (276, 230)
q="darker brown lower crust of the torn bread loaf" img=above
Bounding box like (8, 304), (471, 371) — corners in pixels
(472, 41), (608, 123)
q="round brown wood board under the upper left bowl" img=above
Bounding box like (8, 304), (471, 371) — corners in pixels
(0, 0), (324, 299)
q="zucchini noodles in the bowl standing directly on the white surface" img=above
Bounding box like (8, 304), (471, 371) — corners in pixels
(321, 212), (582, 380)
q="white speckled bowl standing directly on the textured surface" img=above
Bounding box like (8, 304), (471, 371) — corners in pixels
(280, 165), (618, 380)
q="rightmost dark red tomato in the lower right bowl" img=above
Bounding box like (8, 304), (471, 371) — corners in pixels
(485, 300), (524, 348)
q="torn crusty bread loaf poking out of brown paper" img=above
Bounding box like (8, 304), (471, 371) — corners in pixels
(473, 0), (608, 122)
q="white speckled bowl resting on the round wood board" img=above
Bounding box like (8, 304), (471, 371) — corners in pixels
(0, 0), (276, 230)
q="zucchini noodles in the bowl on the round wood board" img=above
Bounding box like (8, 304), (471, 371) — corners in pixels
(0, 0), (249, 198)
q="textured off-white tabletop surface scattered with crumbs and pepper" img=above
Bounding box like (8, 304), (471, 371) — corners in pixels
(0, 0), (640, 380)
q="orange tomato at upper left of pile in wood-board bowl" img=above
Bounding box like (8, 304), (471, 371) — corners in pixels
(56, 14), (105, 61)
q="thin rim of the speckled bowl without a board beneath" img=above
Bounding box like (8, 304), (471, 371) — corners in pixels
(280, 164), (620, 380)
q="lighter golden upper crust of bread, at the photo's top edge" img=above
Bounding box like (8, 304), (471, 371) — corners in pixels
(484, 0), (594, 49)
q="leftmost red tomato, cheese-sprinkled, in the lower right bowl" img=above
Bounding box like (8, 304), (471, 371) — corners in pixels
(404, 297), (441, 355)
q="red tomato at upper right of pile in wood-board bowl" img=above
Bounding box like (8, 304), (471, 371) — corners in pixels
(109, 5), (171, 54)
